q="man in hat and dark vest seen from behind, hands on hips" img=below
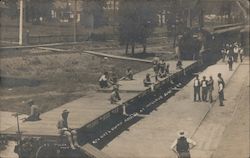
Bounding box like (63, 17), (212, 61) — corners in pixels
(171, 130), (196, 158)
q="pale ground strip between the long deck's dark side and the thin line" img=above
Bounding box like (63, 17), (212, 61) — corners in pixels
(102, 63), (240, 158)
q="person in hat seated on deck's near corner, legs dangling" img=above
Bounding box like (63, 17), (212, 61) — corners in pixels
(57, 109), (80, 149)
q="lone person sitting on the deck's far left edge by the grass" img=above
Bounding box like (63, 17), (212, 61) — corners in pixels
(24, 99), (41, 121)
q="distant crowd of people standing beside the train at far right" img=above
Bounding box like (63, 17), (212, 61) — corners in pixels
(221, 42), (244, 71)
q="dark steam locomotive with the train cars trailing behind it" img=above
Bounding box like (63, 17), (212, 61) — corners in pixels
(177, 23), (244, 64)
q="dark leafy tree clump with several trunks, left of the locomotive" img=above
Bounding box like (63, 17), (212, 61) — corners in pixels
(118, 0), (157, 54)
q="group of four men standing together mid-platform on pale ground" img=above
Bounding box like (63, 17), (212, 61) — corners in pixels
(193, 73), (225, 106)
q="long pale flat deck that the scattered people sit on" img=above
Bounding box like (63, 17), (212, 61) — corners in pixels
(0, 61), (196, 137)
